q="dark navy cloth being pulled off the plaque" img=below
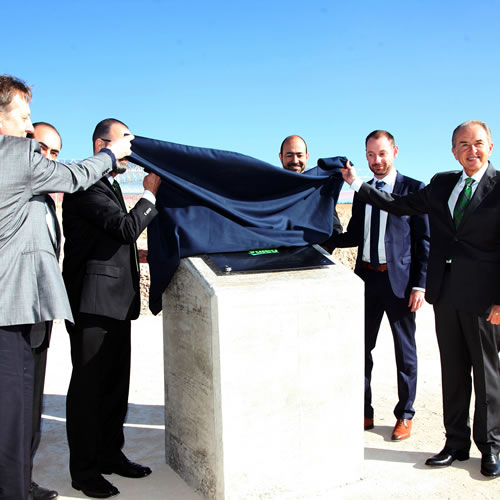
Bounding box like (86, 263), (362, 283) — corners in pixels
(130, 136), (347, 314)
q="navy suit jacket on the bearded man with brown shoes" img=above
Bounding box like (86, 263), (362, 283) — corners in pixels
(326, 172), (429, 298)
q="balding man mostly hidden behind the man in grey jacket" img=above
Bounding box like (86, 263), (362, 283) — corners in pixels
(30, 122), (62, 500)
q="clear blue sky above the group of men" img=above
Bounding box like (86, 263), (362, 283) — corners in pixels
(1, 0), (500, 182)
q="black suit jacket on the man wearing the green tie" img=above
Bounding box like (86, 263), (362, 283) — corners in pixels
(358, 163), (500, 314)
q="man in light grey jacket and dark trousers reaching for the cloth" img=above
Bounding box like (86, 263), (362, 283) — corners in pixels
(0, 75), (133, 500)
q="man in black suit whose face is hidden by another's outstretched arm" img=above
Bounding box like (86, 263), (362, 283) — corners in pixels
(63, 119), (161, 498)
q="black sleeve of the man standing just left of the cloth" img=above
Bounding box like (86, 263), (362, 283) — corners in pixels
(65, 181), (158, 243)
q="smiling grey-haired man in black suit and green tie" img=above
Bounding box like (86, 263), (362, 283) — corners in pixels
(342, 120), (500, 477)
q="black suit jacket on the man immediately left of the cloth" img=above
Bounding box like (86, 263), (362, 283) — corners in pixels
(63, 178), (158, 320)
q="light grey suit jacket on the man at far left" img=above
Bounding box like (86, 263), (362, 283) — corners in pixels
(0, 135), (112, 326)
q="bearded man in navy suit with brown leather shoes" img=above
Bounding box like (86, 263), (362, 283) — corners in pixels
(323, 130), (429, 441)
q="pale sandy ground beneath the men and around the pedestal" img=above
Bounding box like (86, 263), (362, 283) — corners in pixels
(34, 206), (500, 500)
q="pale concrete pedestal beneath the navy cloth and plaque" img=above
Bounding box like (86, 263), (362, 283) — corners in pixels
(163, 248), (364, 500)
